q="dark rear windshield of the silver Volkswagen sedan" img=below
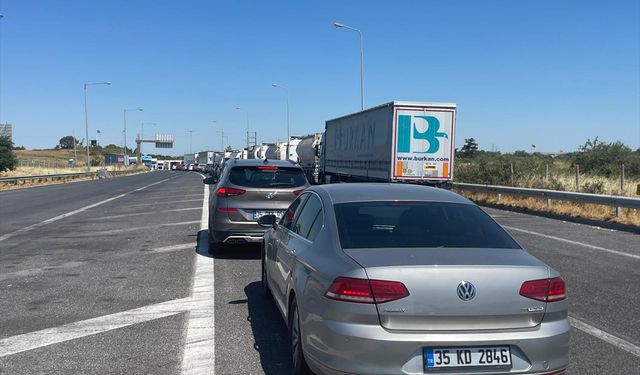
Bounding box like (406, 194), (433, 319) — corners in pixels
(335, 201), (520, 249)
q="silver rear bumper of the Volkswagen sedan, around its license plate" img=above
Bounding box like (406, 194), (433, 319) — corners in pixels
(302, 319), (570, 375)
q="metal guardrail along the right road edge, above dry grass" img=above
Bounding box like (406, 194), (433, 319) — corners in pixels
(453, 182), (640, 215)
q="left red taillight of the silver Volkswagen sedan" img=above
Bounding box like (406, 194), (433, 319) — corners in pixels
(324, 277), (409, 303)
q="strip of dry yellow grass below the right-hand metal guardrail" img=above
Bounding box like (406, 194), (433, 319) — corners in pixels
(462, 191), (640, 228)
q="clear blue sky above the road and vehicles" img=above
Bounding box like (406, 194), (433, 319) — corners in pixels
(0, 0), (640, 155)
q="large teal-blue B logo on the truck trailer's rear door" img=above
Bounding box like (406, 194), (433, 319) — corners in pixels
(398, 115), (449, 154)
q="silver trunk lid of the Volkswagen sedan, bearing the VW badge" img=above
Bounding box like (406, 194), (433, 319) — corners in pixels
(345, 248), (549, 331)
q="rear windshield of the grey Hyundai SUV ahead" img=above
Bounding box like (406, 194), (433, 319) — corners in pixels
(229, 165), (307, 188)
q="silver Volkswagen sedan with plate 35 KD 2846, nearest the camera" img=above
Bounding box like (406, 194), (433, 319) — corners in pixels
(259, 183), (570, 375)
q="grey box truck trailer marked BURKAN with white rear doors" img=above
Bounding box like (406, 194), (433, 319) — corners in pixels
(318, 101), (456, 187)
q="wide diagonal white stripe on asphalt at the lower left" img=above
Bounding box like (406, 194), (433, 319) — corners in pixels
(0, 298), (191, 358)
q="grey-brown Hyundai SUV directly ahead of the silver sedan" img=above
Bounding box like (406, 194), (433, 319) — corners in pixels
(204, 159), (309, 251)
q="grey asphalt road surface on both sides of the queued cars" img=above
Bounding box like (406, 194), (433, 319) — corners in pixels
(0, 172), (640, 375)
